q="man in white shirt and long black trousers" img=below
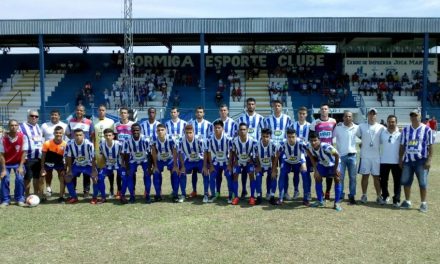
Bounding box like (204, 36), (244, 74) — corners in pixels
(380, 115), (402, 207)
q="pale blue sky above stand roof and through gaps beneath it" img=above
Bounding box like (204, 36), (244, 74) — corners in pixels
(0, 0), (440, 52)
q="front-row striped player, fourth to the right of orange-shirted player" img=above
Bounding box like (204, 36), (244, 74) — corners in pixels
(151, 124), (179, 202)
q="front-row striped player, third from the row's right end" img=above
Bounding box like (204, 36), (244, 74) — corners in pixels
(252, 128), (278, 205)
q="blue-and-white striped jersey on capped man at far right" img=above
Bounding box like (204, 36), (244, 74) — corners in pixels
(400, 123), (434, 162)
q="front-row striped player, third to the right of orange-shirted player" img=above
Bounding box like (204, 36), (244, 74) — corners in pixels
(121, 123), (151, 204)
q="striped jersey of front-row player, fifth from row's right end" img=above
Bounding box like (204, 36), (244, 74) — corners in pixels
(206, 133), (231, 166)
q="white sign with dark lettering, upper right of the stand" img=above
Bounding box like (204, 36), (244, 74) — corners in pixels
(343, 58), (438, 82)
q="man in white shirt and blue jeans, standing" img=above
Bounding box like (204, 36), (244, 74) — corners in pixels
(333, 111), (358, 205)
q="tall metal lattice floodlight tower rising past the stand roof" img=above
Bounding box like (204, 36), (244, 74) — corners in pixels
(123, 0), (135, 108)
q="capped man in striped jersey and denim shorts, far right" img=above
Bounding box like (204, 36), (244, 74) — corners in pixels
(399, 109), (434, 213)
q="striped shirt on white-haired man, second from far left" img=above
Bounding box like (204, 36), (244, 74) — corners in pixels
(19, 123), (44, 159)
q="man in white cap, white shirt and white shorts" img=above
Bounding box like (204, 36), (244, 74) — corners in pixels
(356, 108), (385, 203)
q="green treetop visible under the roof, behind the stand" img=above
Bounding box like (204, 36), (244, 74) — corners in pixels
(240, 45), (329, 54)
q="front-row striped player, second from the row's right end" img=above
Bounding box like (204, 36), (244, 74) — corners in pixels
(278, 128), (311, 206)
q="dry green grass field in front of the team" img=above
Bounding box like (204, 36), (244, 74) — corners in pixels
(0, 156), (440, 263)
